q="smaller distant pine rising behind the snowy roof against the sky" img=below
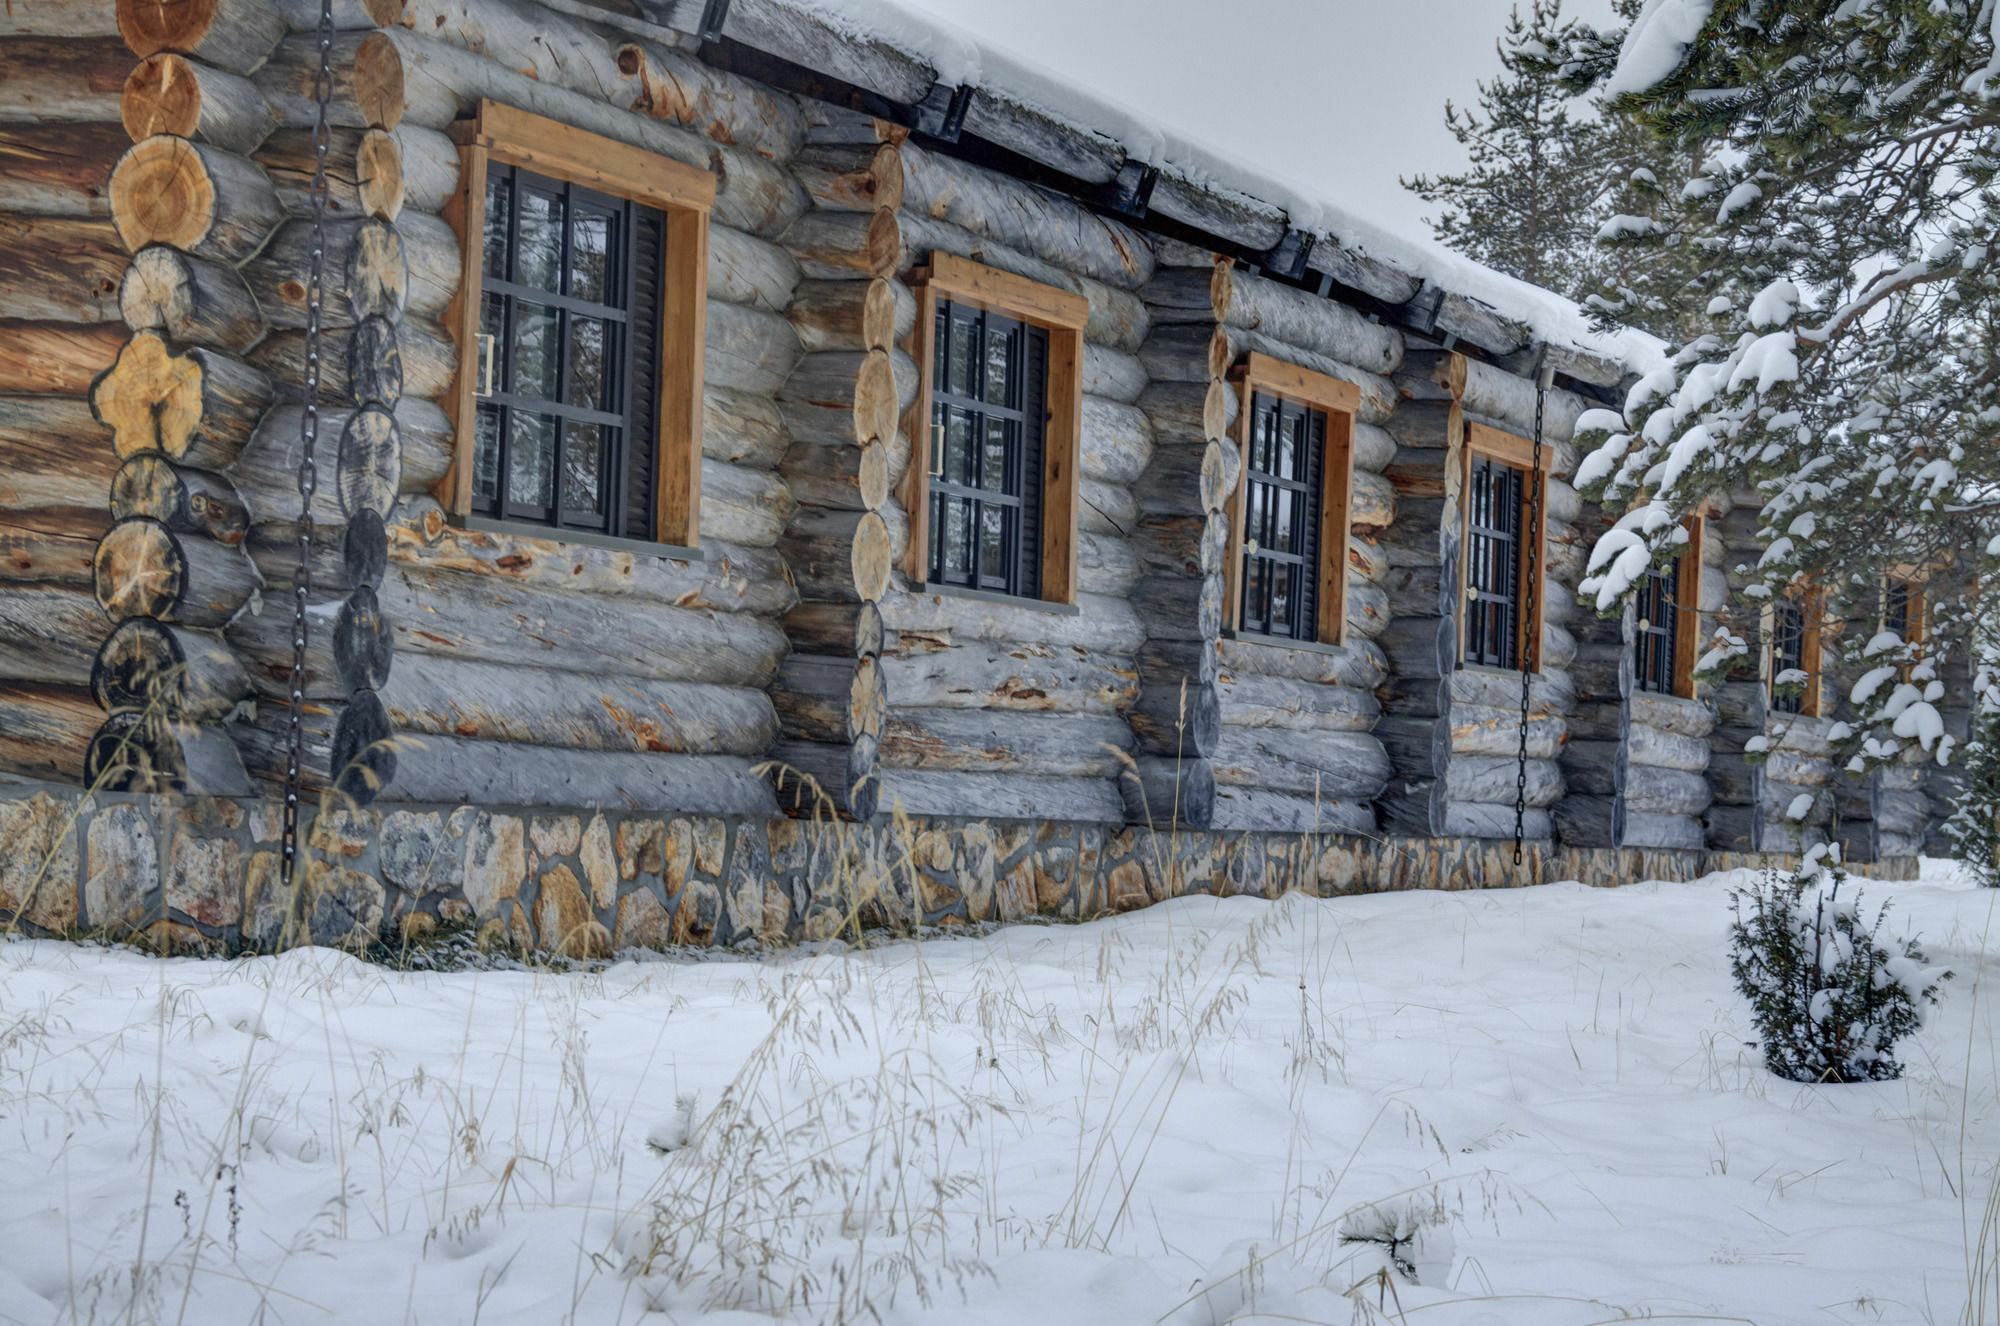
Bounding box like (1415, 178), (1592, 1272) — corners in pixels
(1402, 0), (1604, 298)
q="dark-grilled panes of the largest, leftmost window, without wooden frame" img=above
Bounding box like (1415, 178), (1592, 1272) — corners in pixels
(472, 162), (666, 540)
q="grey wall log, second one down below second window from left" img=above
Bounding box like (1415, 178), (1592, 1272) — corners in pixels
(882, 644), (1138, 714)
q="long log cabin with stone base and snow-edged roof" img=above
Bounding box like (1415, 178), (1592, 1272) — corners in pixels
(0, 0), (1964, 952)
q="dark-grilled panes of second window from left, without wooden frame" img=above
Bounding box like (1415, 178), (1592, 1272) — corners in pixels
(928, 300), (1048, 598)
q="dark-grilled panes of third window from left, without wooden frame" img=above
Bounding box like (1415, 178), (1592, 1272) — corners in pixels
(1242, 392), (1326, 640)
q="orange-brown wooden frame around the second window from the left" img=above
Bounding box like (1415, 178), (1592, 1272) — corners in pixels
(902, 252), (1090, 606)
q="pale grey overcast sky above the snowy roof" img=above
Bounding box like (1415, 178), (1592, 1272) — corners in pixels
(904, 0), (1612, 236)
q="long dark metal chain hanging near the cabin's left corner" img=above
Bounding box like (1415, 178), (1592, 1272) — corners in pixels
(278, 0), (334, 890)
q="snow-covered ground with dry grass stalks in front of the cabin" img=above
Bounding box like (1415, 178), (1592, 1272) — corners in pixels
(0, 866), (2000, 1326)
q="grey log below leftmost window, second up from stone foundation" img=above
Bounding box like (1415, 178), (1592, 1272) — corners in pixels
(372, 654), (778, 756)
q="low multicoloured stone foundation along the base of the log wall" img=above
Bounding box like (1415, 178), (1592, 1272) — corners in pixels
(0, 784), (1916, 956)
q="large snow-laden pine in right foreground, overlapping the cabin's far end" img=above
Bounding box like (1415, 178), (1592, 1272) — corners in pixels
(1568, 0), (2000, 852)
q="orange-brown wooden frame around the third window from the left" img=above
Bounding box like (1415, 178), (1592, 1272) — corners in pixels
(1222, 350), (1362, 646)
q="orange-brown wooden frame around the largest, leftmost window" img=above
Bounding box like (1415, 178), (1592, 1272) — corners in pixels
(438, 100), (716, 548)
